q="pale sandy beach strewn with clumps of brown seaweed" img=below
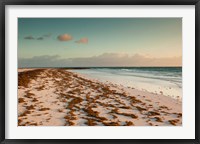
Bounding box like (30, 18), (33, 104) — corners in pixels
(18, 69), (182, 126)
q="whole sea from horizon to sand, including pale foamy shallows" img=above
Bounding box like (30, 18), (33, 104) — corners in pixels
(69, 67), (182, 99)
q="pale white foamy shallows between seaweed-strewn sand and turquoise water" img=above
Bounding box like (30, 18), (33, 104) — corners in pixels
(70, 69), (182, 100)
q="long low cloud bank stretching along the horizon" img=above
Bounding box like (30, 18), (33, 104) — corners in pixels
(19, 53), (182, 67)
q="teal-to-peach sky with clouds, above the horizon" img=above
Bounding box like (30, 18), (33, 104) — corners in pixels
(18, 18), (182, 67)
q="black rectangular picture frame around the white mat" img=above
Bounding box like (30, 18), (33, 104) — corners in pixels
(0, 0), (200, 144)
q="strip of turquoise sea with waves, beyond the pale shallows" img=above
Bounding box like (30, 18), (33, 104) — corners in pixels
(90, 67), (182, 88)
